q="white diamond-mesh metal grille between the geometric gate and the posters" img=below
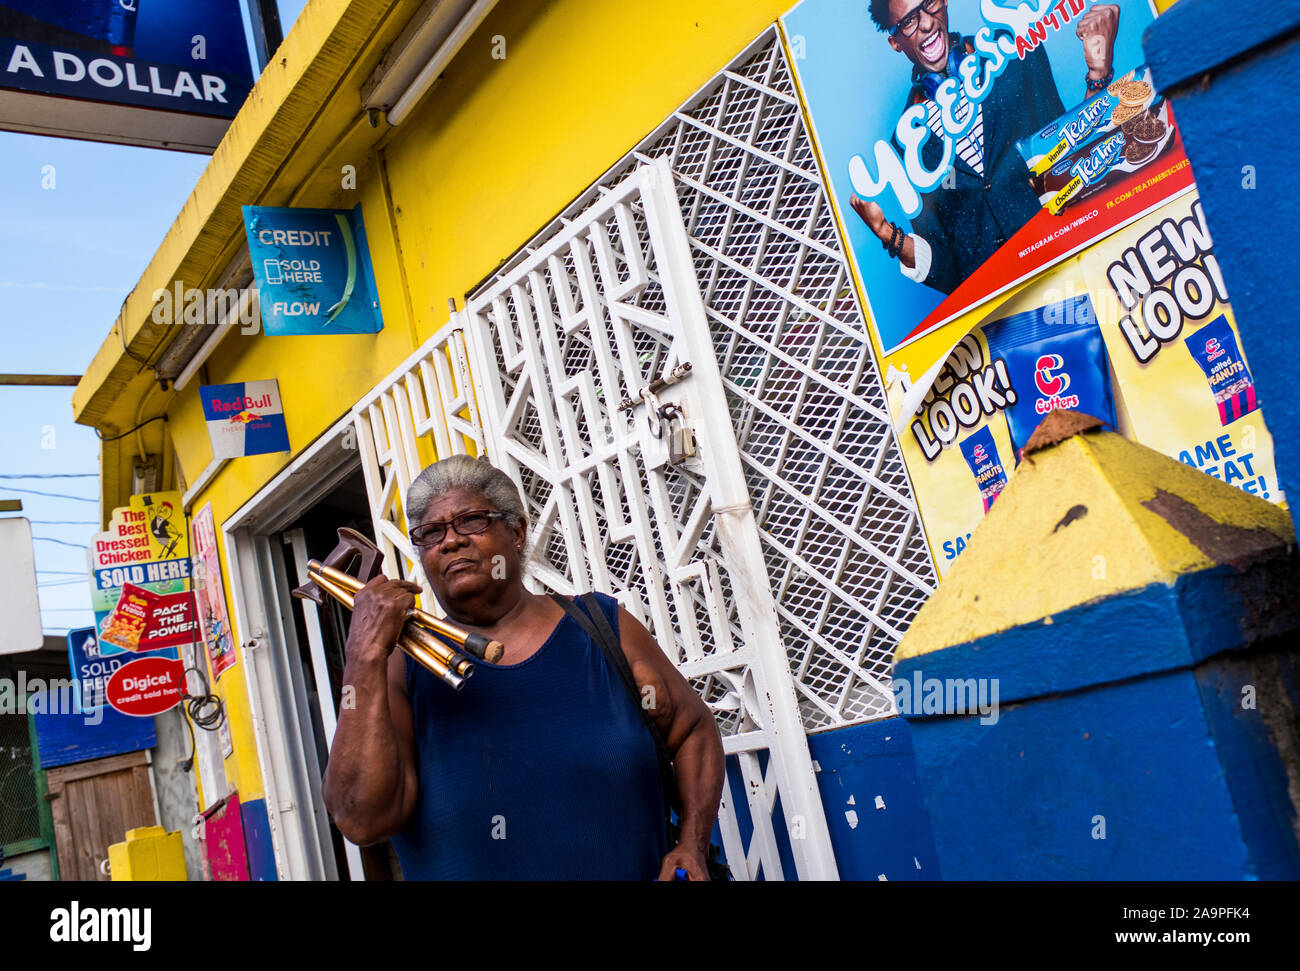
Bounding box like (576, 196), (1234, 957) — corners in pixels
(485, 26), (937, 732)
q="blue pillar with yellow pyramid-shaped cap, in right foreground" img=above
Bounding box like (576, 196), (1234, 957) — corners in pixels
(894, 412), (1300, 880)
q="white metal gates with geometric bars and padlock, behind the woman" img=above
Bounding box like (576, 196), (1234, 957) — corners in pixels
(354, 162), (836, 879)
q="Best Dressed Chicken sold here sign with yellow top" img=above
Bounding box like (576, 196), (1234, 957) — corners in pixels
(90, 491), (192, 658)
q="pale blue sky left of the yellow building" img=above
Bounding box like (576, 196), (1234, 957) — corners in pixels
(0, 0), (307, 634)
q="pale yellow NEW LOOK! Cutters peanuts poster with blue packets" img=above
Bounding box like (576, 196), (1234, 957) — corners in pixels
(888, 192), (1283, 576)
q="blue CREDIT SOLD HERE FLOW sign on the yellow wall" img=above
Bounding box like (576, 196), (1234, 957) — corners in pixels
(243, 205), (384, 337)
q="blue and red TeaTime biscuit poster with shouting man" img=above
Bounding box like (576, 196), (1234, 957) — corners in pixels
(783, 0), (1192, 355)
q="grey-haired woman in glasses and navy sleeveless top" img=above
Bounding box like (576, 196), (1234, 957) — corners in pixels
(324, 456), (723, 880)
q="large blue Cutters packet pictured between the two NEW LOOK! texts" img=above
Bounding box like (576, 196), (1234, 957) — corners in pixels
(984, 294), (1115, 463)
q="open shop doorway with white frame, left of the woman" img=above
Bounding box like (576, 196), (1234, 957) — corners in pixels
(221, 416), (399, 880)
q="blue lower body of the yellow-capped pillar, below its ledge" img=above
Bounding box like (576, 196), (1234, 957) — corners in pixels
(910, 651), (1300, 880)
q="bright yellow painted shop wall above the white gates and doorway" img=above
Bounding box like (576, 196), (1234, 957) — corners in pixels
(168, 0), (790, 801)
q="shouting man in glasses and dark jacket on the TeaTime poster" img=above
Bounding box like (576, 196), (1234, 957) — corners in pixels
(850, 0), (1119, 294)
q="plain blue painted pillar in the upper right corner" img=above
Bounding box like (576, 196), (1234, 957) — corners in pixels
(1144, 0), (1300, 532)
